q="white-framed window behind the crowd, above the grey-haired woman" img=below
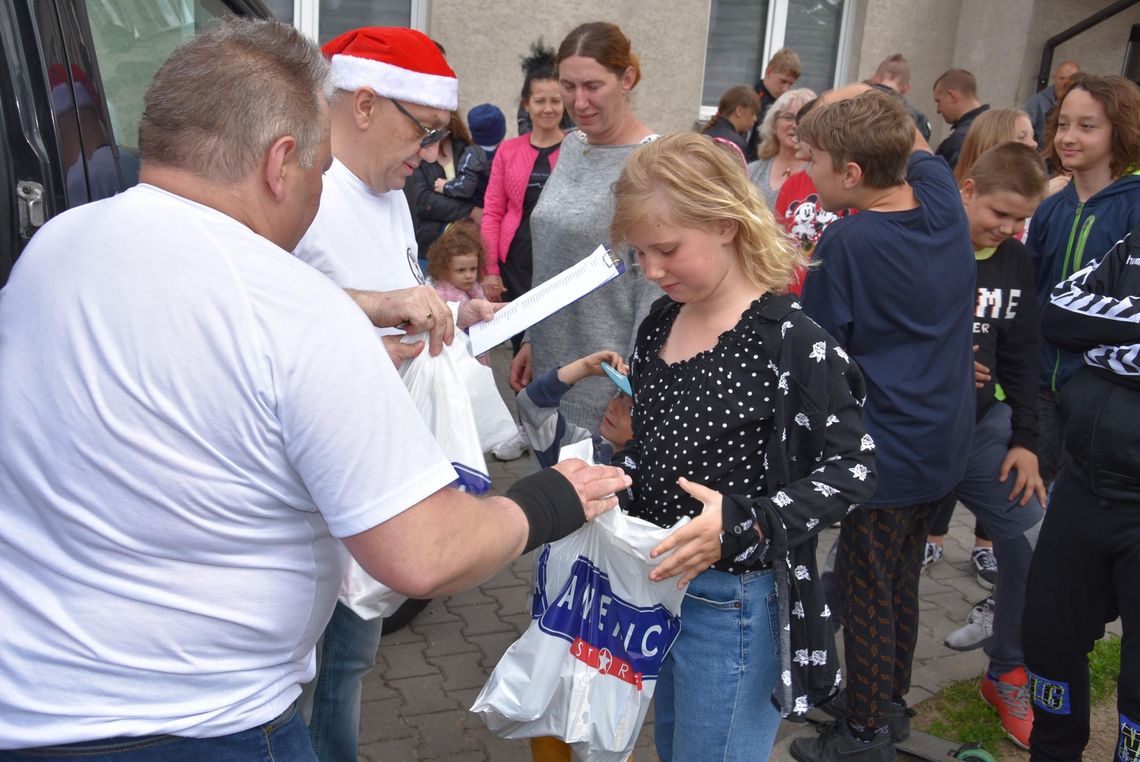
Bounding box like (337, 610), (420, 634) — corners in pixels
(701, 0), (853, 114)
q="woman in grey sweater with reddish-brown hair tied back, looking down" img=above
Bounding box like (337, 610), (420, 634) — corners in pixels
(511, 22), (661, 430)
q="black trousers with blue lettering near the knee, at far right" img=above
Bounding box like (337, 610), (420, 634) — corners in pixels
(1021, 468), (1140, 762)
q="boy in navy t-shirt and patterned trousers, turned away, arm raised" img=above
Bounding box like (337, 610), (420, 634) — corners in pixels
(791, 86), (975, 762)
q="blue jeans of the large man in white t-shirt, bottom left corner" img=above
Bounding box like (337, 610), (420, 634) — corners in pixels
(0, 704), (317, 762)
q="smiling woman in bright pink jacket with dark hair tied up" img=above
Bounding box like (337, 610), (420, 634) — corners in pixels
(482, 41), (563, 354)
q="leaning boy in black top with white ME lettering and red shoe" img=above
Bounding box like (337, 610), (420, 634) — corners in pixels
(946, 143), (1048, 748)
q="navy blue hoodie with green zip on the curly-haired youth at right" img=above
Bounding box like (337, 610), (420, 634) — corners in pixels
(1025, 170), (1140, 392)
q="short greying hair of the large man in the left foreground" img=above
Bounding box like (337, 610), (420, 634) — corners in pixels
(139, 18), (331, 184)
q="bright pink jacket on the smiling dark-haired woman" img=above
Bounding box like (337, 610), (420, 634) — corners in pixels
(482, 133), (559, 275)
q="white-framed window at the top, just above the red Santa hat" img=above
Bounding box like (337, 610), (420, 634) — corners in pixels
(266, 0), (426, 44)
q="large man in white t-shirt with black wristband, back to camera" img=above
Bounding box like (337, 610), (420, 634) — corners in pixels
(0, 21), (628, 762)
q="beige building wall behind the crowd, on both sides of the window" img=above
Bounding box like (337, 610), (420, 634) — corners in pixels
(428, 0), (1140, 145)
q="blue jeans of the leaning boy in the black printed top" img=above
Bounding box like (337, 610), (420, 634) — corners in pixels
(954, 403), (1044, 675)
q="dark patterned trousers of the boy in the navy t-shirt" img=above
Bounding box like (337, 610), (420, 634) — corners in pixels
(836, 500), (943, 728)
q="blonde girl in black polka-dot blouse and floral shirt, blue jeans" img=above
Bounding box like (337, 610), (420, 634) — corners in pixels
(611, 133), (874, 761)
